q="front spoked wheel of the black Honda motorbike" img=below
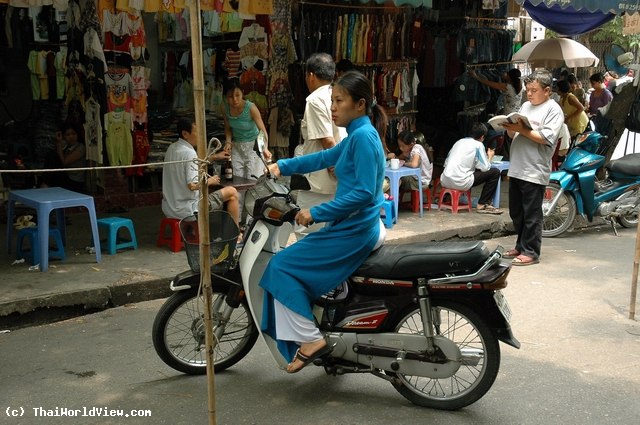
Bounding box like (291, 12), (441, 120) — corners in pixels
(152, 289), (258, 375)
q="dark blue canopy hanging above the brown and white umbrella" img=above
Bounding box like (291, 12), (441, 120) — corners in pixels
(523, 0), (616, 35)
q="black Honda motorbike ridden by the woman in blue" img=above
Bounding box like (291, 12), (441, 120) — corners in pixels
(152, 157), (520, 410)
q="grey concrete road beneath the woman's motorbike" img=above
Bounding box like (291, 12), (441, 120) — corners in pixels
(0, 227), (640, 425)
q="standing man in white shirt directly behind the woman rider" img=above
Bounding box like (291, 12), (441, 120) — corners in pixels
(295, 53), (346, 240)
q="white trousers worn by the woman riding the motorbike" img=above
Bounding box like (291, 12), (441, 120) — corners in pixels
(274, 217), (387, 344)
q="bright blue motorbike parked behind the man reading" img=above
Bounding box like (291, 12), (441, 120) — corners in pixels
(542, 132), (640, 237)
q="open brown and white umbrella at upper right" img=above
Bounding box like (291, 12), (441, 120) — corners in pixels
(512, 38), (600, 68)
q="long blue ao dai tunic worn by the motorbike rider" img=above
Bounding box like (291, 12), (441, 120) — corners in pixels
(260, 116), (385, 361)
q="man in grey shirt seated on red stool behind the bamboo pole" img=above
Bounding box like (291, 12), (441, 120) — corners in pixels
(162, 118), (239, 224)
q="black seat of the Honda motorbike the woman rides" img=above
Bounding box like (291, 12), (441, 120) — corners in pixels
(353, 241), (491, 279)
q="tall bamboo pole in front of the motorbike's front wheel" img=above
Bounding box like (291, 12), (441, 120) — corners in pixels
(189, 0), (216, 425)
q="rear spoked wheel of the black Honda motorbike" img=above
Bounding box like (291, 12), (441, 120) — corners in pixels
(387, 301), (500, 410)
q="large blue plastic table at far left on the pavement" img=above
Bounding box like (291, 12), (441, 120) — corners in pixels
(7, 187), (102, 272)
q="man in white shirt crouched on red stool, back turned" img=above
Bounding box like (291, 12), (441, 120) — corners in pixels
(440, 123), (502, 214)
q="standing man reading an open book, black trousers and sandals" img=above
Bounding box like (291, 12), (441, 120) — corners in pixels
(503, 70), (564, 266)
